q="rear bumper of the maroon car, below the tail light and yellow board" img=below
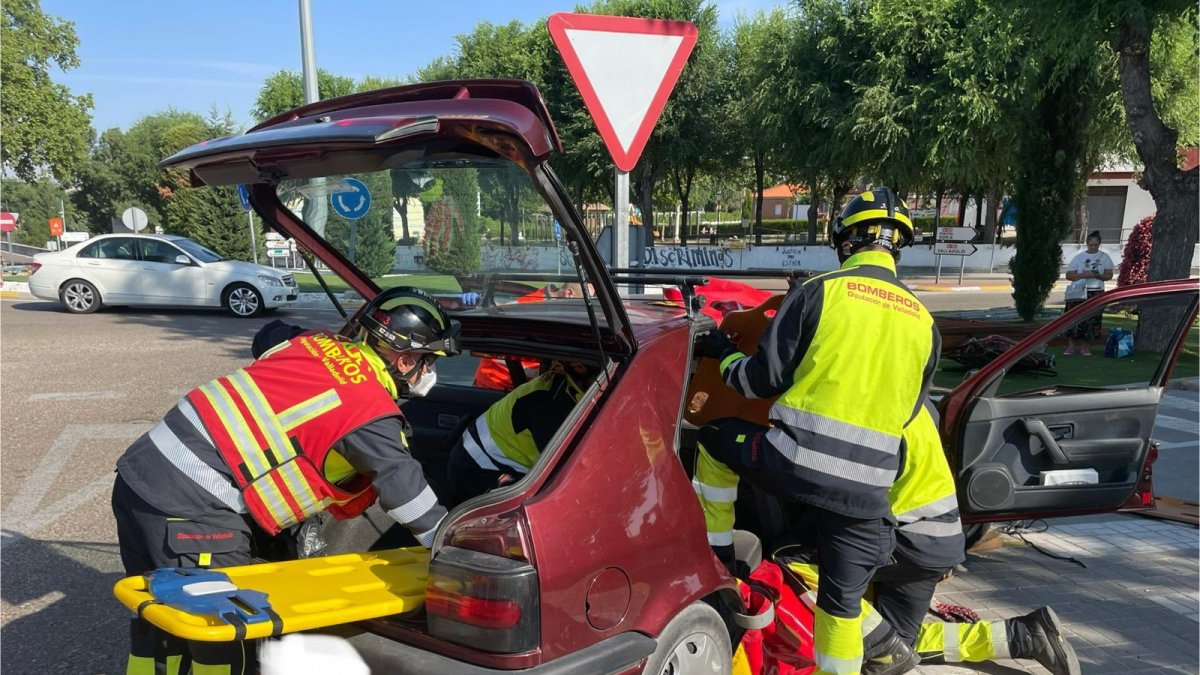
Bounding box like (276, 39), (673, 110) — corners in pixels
(336, 627), (658, 675)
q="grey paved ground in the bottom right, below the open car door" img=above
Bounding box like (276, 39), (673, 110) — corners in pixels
(917, 515), (1200, 675)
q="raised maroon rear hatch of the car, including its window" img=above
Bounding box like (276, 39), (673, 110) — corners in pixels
(161, 79), (636, 354)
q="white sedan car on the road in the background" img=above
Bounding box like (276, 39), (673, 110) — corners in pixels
(29, 234), (299, 317)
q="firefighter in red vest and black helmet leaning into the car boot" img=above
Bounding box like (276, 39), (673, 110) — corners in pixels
(113, 287), (461, 675)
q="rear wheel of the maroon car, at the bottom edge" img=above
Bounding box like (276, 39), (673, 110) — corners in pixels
(642, 601), (733, 675)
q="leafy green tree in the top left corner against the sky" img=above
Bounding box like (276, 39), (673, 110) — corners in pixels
(0, 0), (92, 185)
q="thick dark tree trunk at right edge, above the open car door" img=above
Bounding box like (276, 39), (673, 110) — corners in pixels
(1115, 14), (1200, 281)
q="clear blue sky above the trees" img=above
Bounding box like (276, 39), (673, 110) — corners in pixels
(42, 0), (781, 132)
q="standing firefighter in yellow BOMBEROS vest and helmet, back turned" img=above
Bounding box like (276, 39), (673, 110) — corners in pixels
(696, 187), (941, 674)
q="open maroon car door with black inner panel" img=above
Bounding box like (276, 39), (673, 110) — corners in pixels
(942, 279), (1200, 522)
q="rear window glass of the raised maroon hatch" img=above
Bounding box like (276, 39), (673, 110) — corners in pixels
(277, 155), (582, 310)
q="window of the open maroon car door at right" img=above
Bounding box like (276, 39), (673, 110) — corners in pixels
(979, 293), (1200, 396)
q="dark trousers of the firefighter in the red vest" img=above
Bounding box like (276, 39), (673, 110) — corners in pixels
(113, 476), (257, 675)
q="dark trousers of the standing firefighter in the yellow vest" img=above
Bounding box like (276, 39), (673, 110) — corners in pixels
(700, 418), (895, 619)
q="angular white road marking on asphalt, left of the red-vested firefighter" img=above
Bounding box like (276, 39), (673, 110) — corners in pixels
(0, 423), (148, 536)
